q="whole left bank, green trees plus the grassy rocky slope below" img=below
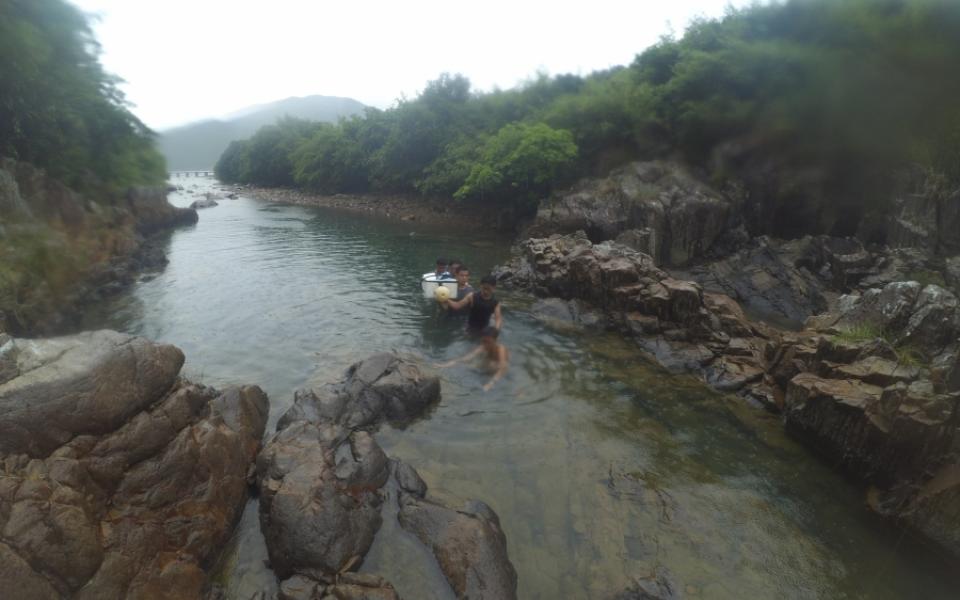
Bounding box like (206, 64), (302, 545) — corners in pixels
(0, 0), (196, 333)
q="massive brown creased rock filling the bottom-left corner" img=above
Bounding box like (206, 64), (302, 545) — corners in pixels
(0, 331), (268, 600)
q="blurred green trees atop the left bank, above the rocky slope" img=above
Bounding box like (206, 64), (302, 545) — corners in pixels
(0, 0), (166, 193)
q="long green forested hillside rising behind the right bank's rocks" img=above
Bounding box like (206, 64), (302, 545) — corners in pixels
(217, 0), (960, 235)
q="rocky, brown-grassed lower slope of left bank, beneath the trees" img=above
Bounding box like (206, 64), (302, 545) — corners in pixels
(0, 158), (197, 334)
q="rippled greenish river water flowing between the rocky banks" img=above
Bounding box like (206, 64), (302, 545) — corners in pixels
(87, 179), (960, 600)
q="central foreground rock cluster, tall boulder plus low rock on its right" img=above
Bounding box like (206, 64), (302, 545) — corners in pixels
(257, 354), (517, 600)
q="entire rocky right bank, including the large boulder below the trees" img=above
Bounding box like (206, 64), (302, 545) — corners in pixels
(497, 163), (960, 560)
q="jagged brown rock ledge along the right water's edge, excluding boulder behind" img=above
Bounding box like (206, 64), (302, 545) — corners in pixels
(496, 232), (960, 557)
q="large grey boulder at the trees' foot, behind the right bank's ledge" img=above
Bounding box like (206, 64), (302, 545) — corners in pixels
(530, 161), (735, 265)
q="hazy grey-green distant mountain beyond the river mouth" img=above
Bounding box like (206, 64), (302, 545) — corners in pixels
(157, 96), (365, 171)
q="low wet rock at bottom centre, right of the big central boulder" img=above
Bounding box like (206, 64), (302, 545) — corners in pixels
(398, 494), (517, 600)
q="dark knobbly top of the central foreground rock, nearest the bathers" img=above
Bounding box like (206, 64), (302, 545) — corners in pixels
(277, 353), (440, 430)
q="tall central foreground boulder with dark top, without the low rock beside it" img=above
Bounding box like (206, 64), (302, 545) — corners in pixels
(257, 353), (440, 583)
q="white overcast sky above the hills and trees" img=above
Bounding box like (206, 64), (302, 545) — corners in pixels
(71, 0), (751, 129)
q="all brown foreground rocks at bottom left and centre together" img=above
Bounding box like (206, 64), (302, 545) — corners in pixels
(0, 331), (517, 600)
